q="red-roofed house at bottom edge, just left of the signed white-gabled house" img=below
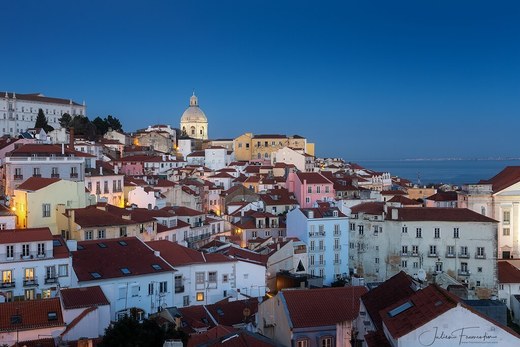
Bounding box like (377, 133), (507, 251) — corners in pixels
(257, 286), (367, 347)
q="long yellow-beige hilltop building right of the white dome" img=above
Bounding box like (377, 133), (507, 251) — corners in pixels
(233, 133), (314, 163)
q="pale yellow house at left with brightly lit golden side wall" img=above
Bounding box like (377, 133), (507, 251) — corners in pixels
(14, 177), (89, 235)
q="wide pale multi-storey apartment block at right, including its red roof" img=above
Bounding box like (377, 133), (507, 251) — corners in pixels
(349, 202), (497, 297)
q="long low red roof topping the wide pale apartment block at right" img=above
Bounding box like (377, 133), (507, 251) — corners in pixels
(386, 207), (498, 223)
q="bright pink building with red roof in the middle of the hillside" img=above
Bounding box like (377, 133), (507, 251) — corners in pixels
(287, 172), (335, 208)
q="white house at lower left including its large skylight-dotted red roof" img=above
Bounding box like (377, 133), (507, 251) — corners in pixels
(71, 237), (175, 320)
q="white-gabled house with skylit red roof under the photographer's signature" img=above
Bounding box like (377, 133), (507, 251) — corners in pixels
(357, 273), (520, 347)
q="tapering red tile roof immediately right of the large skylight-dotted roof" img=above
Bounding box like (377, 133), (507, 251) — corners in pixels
(146, 240), (235, 267)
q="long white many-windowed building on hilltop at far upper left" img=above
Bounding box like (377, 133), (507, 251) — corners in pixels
(0, 92), (87, 136)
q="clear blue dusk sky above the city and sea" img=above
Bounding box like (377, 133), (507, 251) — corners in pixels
(0, 0), (520, 160)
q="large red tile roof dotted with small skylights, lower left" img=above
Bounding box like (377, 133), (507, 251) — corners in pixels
(72, 237), (173, 282)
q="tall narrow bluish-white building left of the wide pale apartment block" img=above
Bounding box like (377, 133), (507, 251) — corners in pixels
(287, 206), (349, 285)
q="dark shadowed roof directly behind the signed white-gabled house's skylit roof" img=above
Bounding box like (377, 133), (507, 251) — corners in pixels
(361, 271), (415, 329)
